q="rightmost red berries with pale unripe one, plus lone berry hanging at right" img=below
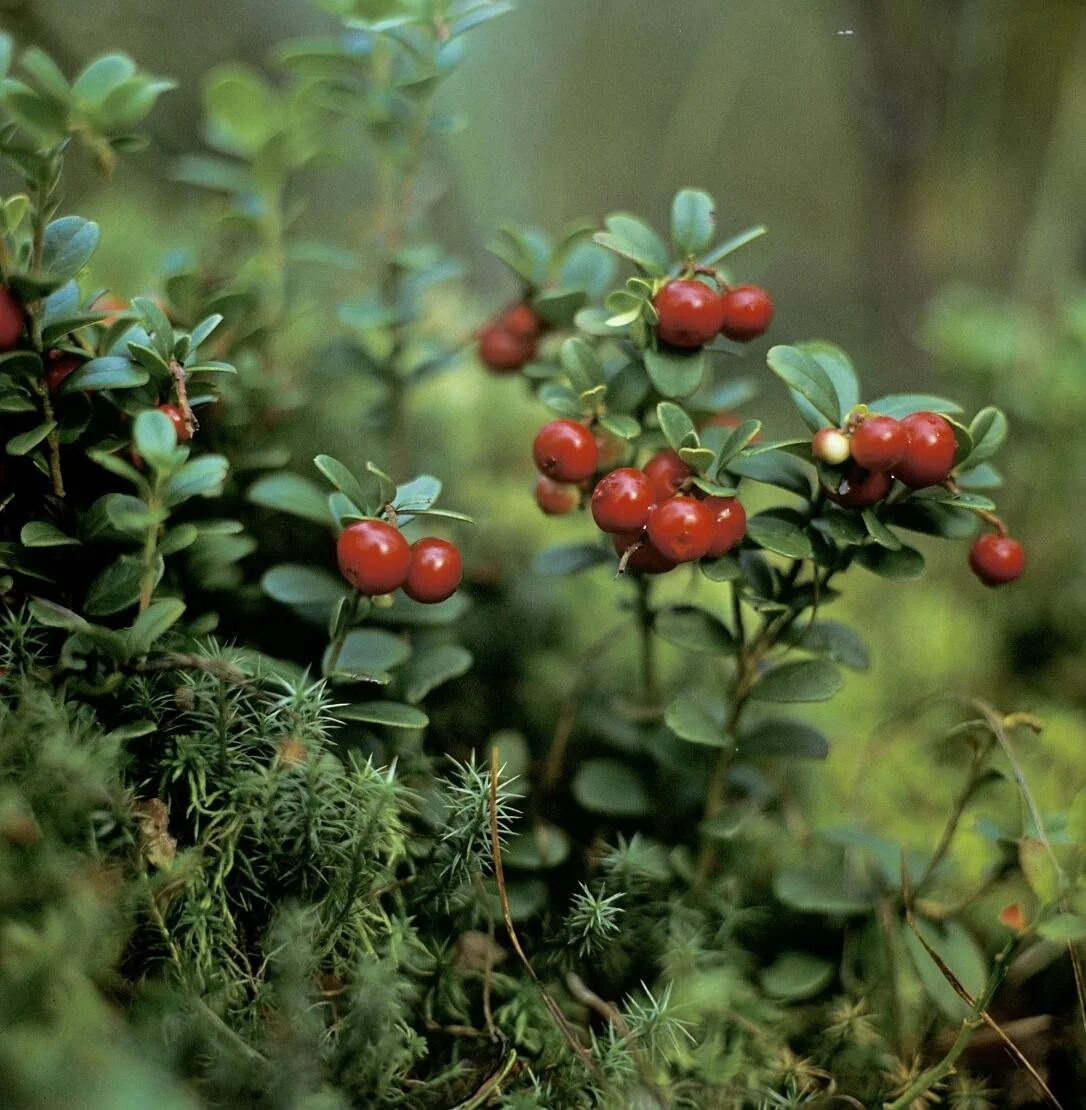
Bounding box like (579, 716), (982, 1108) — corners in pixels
(811, 410), (1026, 586)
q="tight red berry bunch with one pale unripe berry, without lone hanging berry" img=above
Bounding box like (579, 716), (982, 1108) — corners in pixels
(811, 412), (957, 508)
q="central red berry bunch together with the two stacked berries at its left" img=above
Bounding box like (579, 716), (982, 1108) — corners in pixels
(532, 420), (746, 574)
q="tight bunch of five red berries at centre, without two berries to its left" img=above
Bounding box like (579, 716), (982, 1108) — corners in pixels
(592, 450), (746, 574)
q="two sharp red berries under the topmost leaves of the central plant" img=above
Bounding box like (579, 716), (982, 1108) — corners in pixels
(652, 278), (773, 350)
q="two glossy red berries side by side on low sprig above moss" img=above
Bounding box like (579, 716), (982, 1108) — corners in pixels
(335, 519), (463, 605)
